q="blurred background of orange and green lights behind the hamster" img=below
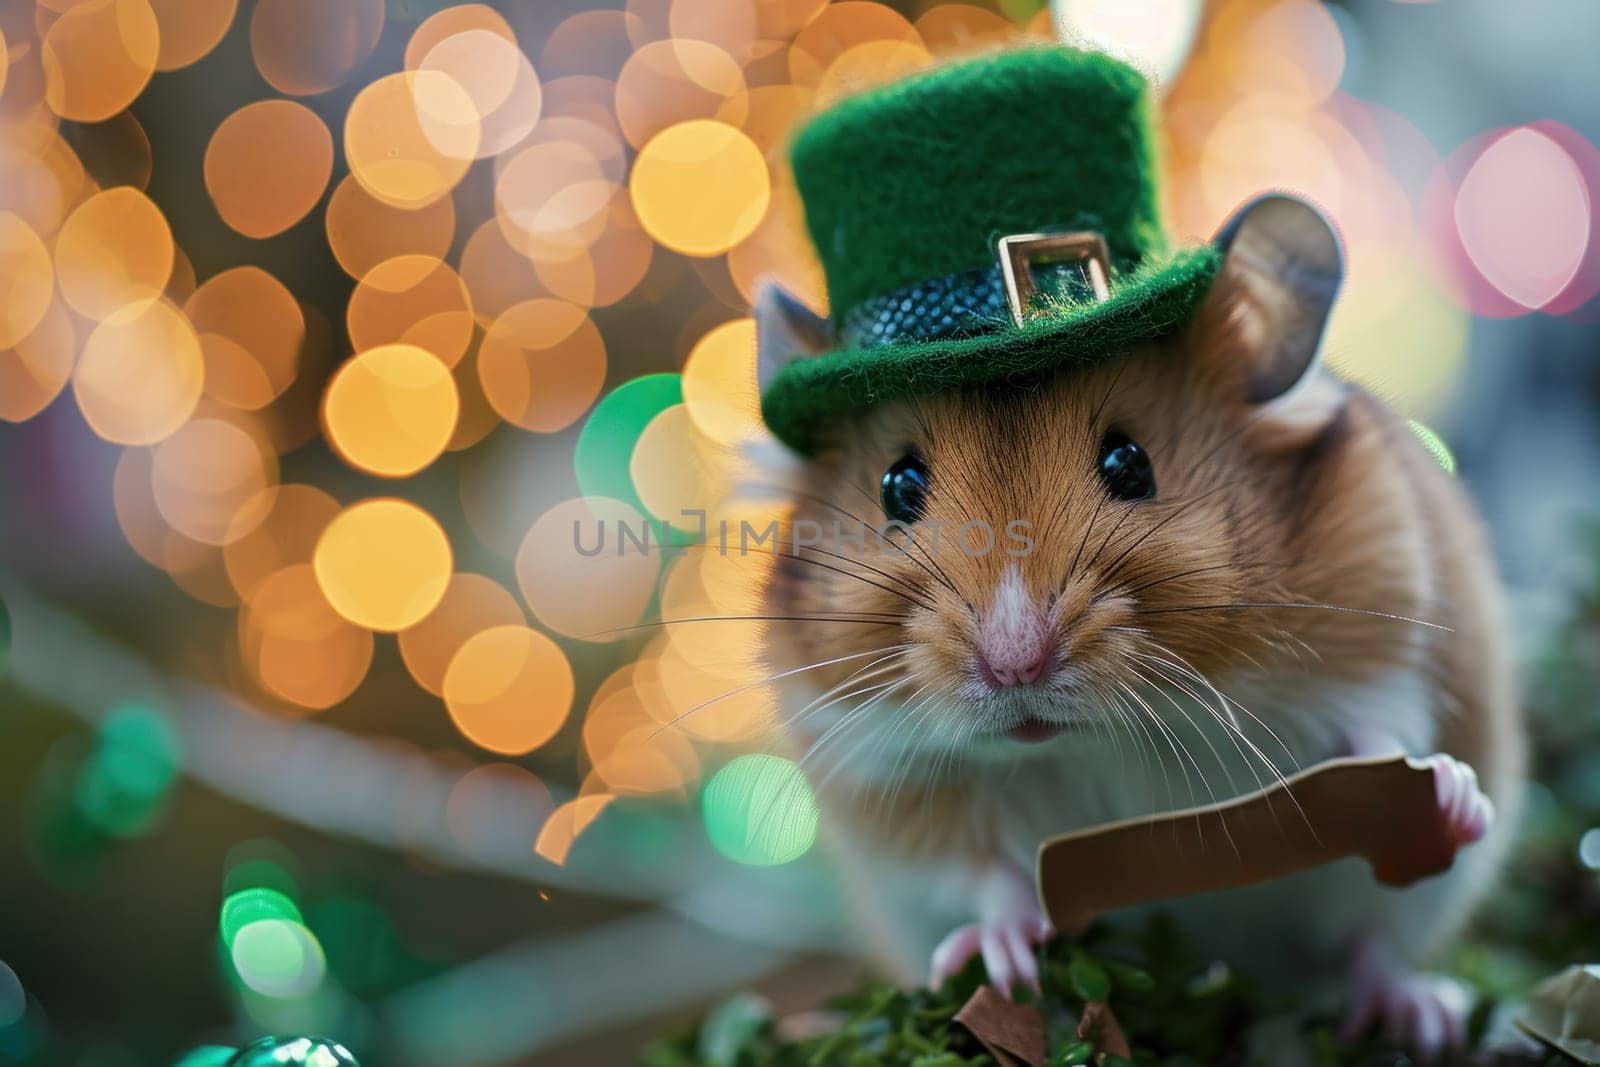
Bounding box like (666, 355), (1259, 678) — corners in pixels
(0, 0), (1600, 1067)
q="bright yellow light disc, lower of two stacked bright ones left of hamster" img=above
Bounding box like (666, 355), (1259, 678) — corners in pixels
(312, 499), (453, 632)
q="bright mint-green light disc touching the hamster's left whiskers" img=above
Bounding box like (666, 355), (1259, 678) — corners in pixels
(701, 753), (818, 867)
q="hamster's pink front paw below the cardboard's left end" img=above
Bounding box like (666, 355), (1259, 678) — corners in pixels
(928, 872), (1056, 1000)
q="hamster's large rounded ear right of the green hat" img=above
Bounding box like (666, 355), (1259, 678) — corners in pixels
(1198, 194), (1344, 403)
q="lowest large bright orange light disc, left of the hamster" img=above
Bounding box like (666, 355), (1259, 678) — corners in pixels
(445, 625), (573, 755)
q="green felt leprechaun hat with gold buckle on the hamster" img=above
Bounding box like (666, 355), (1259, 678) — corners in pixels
(757, 46), (1221, 453)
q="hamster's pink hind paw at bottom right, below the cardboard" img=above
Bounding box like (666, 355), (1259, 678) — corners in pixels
(1339, 968), (1470, 1061)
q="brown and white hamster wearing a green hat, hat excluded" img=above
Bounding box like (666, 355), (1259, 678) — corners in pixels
(757, 197), (1523, 1056)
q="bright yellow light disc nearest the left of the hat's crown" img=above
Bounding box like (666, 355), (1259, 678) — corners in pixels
(629, 120), (771, 256)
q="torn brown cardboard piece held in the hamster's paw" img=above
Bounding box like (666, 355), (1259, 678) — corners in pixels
(1038, 755), (1456, 931)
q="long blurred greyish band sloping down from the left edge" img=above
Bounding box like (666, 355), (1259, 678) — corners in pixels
(0, 582), (842, 958)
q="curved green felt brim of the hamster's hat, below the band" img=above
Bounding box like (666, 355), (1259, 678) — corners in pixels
(762, 245), (1222, 454)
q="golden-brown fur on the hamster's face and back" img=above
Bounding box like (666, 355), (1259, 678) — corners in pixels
(768, 271), (1522, 910)
